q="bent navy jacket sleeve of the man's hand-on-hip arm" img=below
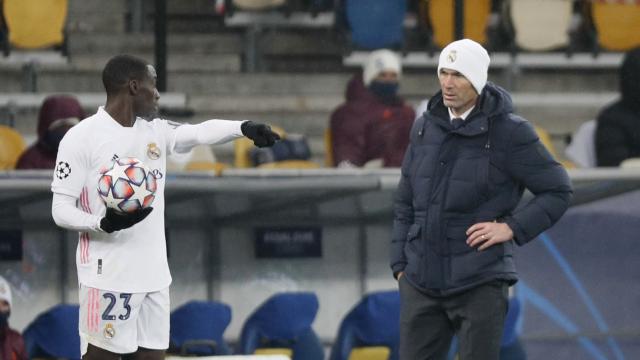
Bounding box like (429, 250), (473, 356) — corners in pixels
(504, 121), (573, 245)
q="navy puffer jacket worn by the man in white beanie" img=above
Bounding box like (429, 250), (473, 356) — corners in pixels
(391, 83), (572, 296)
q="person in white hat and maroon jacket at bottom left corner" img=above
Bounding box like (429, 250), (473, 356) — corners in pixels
(0, 276), (27, 360)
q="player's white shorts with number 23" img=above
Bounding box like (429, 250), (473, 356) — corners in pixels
(79, 285), (170, 355)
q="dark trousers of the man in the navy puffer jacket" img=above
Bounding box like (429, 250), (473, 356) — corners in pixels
(399, 276), (508, 360)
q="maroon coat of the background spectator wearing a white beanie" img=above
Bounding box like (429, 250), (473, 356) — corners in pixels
(330, 74), (415, 167)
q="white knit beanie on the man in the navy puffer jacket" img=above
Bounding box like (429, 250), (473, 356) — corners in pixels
(438, 39), (490, 94)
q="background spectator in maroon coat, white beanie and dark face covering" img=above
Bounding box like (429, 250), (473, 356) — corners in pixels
(329, 49), (415, 167)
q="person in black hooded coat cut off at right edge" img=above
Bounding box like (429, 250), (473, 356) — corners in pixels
(595, 48), (640, 166)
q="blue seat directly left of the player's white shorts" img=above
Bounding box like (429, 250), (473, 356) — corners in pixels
(23, 305), (80, 359)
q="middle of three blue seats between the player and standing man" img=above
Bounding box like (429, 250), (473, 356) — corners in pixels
(238, 292), (324, 360)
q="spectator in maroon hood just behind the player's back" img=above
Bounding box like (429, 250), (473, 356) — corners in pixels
(16, 95), (85, 169)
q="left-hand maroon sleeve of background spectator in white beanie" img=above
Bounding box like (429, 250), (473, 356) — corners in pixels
(331, 106), (368, 166)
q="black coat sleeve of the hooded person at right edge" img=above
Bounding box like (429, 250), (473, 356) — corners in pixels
(596, 119), (631, 166)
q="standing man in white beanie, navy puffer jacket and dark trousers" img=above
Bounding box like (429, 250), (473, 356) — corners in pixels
(390, 39), (572, 360)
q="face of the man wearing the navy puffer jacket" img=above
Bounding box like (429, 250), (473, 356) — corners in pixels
(438, 68), (478, 115)
